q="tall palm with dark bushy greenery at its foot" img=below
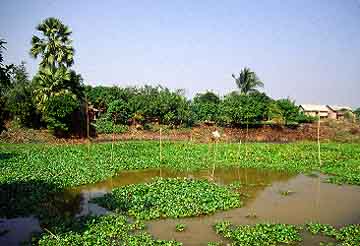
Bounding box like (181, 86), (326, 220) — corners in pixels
(30, 18), (84, 135)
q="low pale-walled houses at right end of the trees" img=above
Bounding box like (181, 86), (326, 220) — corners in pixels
(299, 104), (354, 120)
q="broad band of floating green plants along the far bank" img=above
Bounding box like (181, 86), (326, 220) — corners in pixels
(0, 141), (360, 188)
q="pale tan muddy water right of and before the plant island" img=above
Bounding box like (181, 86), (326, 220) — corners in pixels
(148, 175), (360, 245)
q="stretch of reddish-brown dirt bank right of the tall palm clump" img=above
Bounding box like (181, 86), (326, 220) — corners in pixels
(95, 121), (360, 142)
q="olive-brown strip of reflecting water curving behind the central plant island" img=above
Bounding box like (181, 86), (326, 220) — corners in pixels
(67, 167), (292, 215)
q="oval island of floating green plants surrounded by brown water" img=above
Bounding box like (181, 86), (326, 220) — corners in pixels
(94, 178), (242, 220)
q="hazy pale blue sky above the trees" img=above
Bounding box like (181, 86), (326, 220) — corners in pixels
(0, 0), (360, 106)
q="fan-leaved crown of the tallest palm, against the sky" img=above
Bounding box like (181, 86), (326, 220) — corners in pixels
(30, 17), (75, 68)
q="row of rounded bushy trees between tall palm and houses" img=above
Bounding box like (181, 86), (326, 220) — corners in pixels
(86, 86), (314, 131)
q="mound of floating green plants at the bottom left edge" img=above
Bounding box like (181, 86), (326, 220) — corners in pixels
(38, 215), (182, 246)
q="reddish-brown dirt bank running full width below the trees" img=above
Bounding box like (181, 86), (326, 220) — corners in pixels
(0, 121), (360, 144)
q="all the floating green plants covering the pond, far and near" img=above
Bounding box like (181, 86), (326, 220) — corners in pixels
(0, 141), (360, 245)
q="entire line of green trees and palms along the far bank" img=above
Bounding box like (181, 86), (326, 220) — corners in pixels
(0, 18), (360, 136)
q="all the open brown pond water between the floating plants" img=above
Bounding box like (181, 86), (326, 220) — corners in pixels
(0, 168), (360, 245)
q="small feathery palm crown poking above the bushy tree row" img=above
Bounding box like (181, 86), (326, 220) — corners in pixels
(232, 67), (264, 95)
